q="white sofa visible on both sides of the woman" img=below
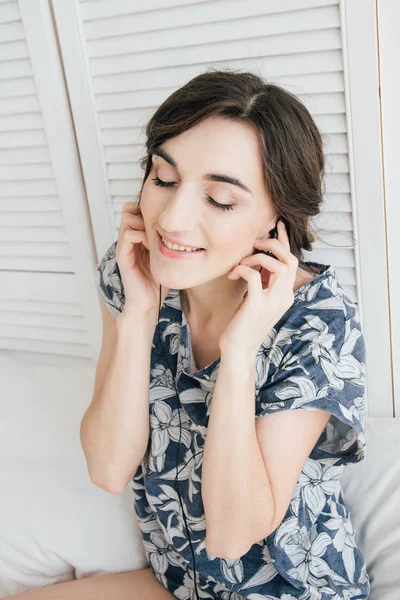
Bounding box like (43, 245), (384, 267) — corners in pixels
(0, 354), (400, 600)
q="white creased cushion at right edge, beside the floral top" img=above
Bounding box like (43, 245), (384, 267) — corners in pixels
(341, 417), (400, 600)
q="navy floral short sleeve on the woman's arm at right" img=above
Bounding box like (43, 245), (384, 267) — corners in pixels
(256, 301), (366, 465)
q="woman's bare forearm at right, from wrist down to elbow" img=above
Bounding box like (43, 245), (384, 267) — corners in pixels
(202, 356), (273, 558)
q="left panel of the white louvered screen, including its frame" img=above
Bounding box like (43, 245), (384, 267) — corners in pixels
(0, 0), (101, 362)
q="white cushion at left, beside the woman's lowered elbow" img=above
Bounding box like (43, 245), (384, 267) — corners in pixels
(0, 355), (148, 598)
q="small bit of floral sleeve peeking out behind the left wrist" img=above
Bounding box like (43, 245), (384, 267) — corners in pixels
(96, 240), (125, 318)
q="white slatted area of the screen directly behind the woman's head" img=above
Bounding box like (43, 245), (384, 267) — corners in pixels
(61, 0), (357, 302)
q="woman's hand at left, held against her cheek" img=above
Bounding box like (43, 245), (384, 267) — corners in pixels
(115, 202), (170, 315)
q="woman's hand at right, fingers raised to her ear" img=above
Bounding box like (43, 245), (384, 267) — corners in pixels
(219, 221), (299, 358)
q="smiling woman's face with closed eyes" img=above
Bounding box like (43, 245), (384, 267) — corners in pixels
(140, 117), (276, 289)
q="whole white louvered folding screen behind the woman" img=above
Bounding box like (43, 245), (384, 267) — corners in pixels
(0, 0), (393, 416)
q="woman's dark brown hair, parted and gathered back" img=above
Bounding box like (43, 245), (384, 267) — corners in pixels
(137, 69), (325, 271)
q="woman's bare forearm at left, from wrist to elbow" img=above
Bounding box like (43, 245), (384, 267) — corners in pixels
(80, 308), (156, 493)
